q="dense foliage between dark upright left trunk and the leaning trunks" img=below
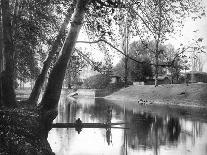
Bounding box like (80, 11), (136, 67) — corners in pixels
(10, 0), (73, 81)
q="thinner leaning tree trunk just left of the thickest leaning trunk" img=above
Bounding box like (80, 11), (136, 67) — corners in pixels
(28, 1), (75, 104)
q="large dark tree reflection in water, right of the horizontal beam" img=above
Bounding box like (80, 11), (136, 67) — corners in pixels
(127, 112), (181, 151)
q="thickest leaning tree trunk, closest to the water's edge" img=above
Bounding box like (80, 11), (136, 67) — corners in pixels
(39, 0), (89, 111)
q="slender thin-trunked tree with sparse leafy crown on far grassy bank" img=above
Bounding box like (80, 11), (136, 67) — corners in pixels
(125, 0), (201, 86)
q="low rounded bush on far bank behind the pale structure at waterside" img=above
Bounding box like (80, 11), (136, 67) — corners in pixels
(83, 74), (111, 89)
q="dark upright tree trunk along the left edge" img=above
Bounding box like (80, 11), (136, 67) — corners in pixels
(0, 0), (16, 107)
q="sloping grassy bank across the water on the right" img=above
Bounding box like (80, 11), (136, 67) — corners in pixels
(105, 83), (207, 107)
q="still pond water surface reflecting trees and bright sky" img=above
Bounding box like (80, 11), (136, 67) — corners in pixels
(48, 97), (207, 155)
